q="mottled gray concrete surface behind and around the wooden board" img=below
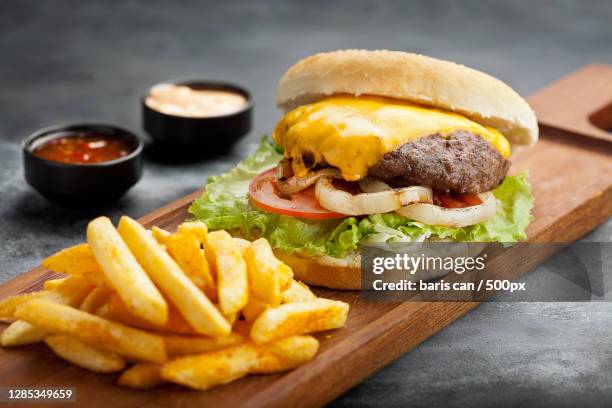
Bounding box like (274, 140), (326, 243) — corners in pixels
(0, 0), (612, 407)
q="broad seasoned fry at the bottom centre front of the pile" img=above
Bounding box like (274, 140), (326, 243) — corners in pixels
(161, 345), (257, 390)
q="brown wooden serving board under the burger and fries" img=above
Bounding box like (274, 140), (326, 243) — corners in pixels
(0, 66), (612, 407)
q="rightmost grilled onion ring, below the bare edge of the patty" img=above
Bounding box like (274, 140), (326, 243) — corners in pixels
(396, 192), (497, 227)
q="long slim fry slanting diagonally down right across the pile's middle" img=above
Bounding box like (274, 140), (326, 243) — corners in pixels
(119, 216), (231, 336)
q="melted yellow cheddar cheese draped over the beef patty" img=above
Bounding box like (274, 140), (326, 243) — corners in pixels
(273, 96), (510, 180)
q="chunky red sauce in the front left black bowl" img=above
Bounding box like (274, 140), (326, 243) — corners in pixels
(32, 132), (134, 164)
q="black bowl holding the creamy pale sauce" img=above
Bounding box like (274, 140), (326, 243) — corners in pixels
(141, 80), (253, 157)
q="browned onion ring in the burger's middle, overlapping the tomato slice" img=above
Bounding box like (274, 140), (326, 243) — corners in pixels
(315, 176), (433, 215)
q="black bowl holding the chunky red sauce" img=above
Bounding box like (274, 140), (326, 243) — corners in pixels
(22, 124), (143, 208)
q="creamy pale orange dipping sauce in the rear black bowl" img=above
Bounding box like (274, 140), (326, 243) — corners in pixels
(145, 84), (247, 118)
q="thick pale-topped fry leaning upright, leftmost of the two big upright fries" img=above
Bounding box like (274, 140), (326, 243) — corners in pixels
(87, 217), (168, 325)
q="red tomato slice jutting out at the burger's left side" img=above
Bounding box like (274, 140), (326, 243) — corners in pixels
(249, 168), (347, 220)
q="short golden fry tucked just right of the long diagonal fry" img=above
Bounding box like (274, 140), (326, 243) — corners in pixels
(166, 232), (217, 301)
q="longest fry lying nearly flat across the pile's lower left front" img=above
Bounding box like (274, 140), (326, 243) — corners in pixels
(15, 299), (166, 363)
